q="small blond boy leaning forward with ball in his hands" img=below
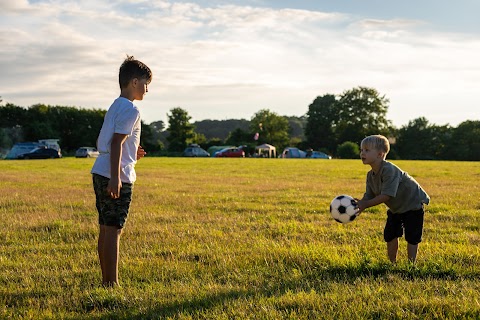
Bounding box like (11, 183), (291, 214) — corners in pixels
(357, 135), (430, 263)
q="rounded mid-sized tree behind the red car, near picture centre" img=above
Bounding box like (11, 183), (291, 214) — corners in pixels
(250, 109), (289, 149)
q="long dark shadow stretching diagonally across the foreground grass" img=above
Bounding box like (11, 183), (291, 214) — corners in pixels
(76, 261), (480, 319)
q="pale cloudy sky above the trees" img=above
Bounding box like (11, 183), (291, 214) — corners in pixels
(0, 0), (480, 127)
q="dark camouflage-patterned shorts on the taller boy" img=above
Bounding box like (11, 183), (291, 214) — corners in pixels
(92, 174), (133, 229)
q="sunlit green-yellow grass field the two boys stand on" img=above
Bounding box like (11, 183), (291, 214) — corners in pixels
(0, 158), (480, 319)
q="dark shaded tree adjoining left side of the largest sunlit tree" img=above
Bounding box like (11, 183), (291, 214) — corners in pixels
(305, 94), (339, 152)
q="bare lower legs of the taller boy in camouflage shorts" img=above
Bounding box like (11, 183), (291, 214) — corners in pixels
(103, 226), (122, 286)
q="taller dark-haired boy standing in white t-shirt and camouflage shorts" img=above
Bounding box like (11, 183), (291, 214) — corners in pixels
(91, 57), (152, 286)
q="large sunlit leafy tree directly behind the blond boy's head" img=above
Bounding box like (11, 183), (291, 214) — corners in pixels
(335, 87), (392, 144)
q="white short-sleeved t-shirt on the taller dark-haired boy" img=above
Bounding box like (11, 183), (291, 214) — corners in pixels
(91, 97), (141, 183)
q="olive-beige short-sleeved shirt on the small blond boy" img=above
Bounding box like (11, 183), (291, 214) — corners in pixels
(363, 160), (430, 213)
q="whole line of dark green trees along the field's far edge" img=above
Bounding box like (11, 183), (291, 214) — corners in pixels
(0, 87), (480, 161)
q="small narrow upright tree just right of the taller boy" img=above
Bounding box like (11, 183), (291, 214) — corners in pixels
(167, 107), (195, 152)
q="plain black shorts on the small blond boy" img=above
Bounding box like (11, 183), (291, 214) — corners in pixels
(383, 208), (424, 245)
